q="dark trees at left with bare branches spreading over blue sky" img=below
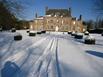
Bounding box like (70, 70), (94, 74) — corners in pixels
(0, 0), (28, 30)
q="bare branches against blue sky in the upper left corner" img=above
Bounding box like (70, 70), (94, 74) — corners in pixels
(0, 0), (24, 17)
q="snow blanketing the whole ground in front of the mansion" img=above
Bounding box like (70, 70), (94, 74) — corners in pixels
(0, 30), (103, 77)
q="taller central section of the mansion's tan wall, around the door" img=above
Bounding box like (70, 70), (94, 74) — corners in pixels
(45, 17), (71, 31)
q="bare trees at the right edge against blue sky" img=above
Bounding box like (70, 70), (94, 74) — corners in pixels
(84, 0), (103, 30)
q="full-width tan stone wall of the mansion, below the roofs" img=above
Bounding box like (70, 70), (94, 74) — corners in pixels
(31, 17), (83, 32)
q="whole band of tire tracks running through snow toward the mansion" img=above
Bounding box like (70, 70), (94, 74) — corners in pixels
(27, 38), (61, 77)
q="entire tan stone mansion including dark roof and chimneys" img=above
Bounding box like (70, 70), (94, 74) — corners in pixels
(30, 7), (84, 32)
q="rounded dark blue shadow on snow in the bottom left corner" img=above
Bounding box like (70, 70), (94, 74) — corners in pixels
(1, 61), (20, 77)
